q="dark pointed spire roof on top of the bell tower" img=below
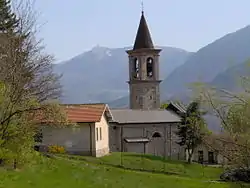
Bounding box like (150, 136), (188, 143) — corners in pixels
(133, 12), (154, 50)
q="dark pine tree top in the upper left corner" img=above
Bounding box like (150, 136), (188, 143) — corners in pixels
(0, 0), (18, 33)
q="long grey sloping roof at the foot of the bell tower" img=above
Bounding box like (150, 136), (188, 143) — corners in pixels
(110, 109), (181, 124)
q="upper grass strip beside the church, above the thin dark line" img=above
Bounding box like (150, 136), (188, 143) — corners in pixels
(69, 153), (222, 180)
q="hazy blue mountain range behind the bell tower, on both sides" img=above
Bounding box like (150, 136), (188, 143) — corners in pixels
(54, 26), (250, 130)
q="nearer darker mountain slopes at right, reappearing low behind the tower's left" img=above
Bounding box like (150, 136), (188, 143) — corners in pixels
(88, 26), (250, 108)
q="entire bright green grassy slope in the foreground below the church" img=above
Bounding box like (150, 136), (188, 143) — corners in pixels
(0, 153), (244, 188)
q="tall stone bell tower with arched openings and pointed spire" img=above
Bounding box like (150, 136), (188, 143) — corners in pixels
(127, 11), (161, 110)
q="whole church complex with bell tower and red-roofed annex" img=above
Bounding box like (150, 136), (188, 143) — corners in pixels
(40, 11), (185, 159)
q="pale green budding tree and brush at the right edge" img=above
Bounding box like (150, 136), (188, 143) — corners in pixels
(191, 77), (250, 168)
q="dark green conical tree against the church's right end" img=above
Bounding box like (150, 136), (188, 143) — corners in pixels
(177, 101), (207, 163)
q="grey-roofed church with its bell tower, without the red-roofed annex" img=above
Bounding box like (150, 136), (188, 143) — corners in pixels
(109, 11), (183, 158)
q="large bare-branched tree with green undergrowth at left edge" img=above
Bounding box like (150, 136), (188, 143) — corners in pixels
(0, 0), (66, 168)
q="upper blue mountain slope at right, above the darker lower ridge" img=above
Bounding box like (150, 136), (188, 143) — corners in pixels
(161, 26), (250, 99)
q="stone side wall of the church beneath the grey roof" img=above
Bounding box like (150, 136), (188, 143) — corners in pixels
(110, 123), (185, 160)
